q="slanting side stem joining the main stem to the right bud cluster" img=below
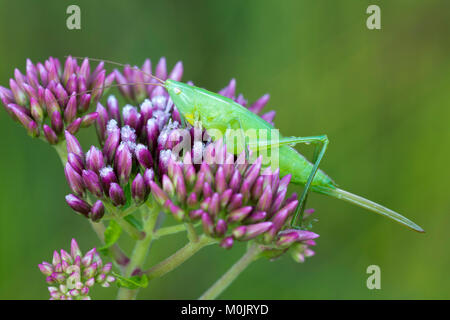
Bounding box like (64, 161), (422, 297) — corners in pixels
(144, 235), (216, 280)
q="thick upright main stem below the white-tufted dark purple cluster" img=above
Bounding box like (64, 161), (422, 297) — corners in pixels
(117, 209), (159, 300)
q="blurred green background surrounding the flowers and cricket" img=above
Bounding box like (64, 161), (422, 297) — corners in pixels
(0, 0), (450, 299)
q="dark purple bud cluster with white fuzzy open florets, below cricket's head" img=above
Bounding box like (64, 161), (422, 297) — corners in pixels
(65, 90), (173, 221)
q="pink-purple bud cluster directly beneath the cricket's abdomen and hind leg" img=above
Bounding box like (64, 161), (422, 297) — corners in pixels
(150, 132), (318, 261)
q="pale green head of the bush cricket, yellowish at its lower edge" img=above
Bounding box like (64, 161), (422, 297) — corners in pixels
(164, 79), (195, 124)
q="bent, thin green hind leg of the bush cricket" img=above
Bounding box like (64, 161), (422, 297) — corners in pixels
(250, 135), (329, 227)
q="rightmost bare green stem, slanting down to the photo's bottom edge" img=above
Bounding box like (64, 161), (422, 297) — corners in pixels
(199, 244), (262, 300)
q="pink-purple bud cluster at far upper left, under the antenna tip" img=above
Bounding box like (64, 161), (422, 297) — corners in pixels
(0, 57), (115, 144)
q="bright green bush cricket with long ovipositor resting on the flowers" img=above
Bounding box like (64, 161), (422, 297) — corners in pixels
(74, 58), (424, 232)
